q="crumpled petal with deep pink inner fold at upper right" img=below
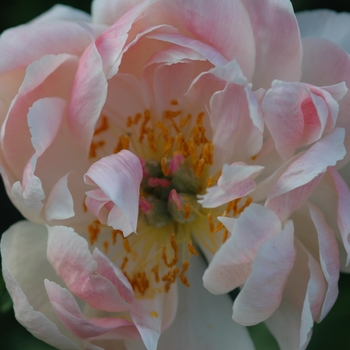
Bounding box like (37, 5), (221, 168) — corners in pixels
(262, 80), (347, 159)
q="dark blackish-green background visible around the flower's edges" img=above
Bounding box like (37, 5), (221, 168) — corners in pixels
(0, 0), (350, 350)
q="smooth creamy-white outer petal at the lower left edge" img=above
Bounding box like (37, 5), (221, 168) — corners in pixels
(1, 221), (80, 350)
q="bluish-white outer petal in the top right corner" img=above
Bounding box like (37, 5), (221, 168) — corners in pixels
(296, 9), (350, 52)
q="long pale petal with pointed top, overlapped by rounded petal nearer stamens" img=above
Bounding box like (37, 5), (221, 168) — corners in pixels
(232, 221), (296, 326)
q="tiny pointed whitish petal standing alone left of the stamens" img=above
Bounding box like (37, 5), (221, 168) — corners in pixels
(45, 174), (75, 221)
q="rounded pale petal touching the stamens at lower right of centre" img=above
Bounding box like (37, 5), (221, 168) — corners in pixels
(203, 203), (281, 294)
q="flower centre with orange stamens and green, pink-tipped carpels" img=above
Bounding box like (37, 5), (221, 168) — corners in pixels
(89, 100), (249, 298)
